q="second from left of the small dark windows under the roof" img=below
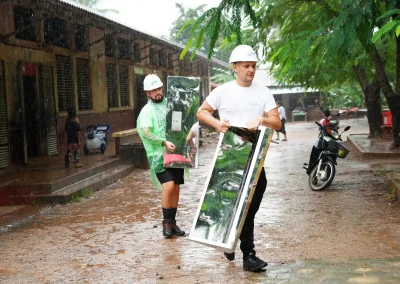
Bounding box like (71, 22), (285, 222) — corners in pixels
(44, 16), (69, 48)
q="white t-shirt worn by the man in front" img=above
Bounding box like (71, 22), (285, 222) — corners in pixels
(207, 81), (276, 127)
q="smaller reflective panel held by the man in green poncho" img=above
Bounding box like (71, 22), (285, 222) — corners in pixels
(164, 76), (200, 168)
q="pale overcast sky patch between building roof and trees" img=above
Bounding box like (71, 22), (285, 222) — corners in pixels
(97, 0), (221, 37)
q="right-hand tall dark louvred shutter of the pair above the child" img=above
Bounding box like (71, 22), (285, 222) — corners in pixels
(75, 58), (92, 110)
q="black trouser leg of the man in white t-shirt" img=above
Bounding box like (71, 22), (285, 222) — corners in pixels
(240, 168), (267, 256)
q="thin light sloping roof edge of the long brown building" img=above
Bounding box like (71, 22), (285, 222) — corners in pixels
(57, 0), (229, 67)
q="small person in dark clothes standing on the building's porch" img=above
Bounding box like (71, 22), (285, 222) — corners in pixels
(65, 108), (82, 168)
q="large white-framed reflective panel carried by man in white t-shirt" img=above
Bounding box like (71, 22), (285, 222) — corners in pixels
(190, 128), (272, 249)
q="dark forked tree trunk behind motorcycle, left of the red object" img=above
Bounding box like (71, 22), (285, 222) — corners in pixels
(353, 66), (382, 138)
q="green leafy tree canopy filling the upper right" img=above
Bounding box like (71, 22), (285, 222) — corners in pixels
(182, 0), (400, 114)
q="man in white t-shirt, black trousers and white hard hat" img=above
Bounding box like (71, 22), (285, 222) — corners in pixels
(197, 45), (281, 272)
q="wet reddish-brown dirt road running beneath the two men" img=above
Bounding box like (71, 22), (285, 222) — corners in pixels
(0, 117), (400, 283)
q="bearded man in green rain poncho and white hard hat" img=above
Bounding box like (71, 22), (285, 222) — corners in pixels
(137, 74), (185, 238)
